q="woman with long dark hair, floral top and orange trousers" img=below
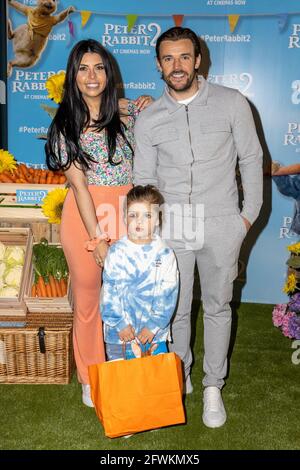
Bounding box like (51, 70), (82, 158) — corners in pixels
(46, 39), (151, 407)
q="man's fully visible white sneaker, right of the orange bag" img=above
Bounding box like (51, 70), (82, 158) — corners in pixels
(202, 387), (227, 428)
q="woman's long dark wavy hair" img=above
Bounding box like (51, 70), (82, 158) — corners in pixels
(45, 39), (132, 170)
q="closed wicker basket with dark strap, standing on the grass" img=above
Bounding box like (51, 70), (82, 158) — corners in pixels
(0, 324), (74, 384)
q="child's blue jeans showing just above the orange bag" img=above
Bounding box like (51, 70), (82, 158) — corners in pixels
(105, 341), (168, 361)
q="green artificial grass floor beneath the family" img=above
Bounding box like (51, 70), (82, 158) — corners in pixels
(0, 304), (300, 452)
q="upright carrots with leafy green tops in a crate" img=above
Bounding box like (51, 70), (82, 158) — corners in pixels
(31, 238), (69, 297)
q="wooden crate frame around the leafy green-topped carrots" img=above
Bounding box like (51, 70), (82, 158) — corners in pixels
(24, 243), (73, 313)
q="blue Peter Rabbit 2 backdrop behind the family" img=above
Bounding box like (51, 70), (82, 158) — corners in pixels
(8, 0), (300, 303)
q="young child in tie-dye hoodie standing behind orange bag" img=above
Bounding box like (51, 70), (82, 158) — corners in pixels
(100, 185), (178, 360)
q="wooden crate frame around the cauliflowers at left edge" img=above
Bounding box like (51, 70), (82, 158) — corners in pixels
(0, 228), (33, 317)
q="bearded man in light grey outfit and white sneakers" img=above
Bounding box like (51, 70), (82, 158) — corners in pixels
(134, 27), (262, 427)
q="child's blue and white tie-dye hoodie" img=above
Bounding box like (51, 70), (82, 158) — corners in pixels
(100, 236), (178, 344)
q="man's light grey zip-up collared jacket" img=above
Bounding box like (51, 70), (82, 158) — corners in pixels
(134, 77), (262, 223)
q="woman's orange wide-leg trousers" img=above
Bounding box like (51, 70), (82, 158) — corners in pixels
(61, 185), (131, 384)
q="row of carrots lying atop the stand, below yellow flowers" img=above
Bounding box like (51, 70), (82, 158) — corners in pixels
(0, 163), (66, 184)
